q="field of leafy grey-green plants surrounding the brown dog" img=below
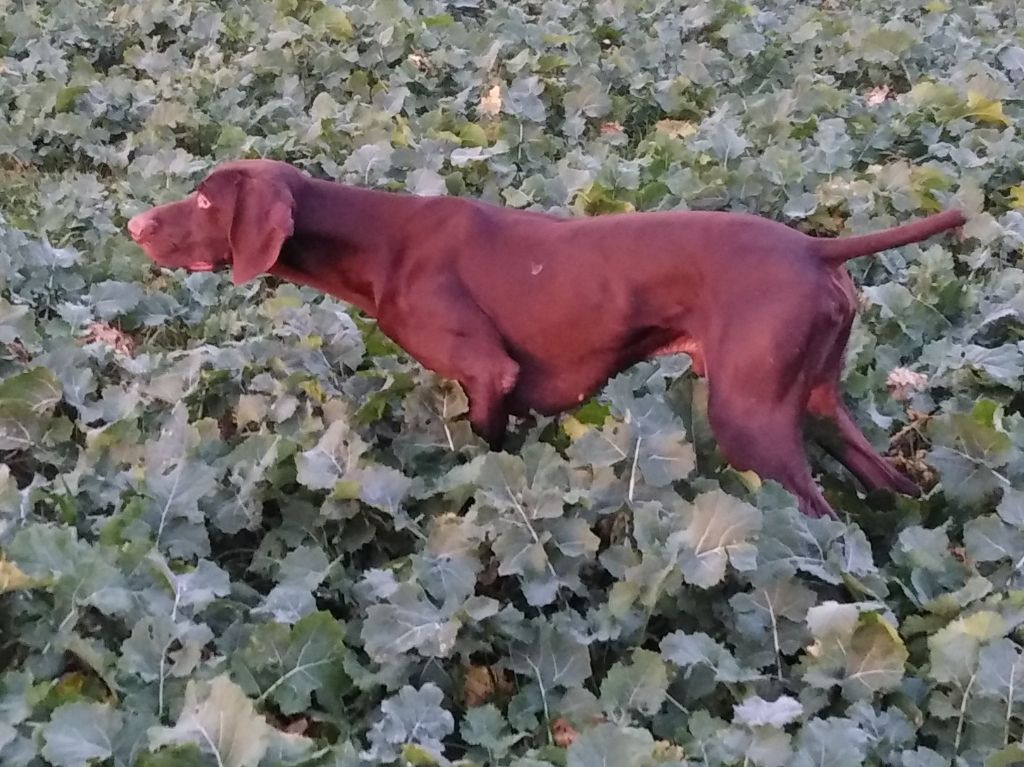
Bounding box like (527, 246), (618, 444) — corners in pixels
(0, 0), (1024, 767)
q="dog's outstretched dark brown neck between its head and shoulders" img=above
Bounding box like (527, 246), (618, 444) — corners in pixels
(270, 178), (429, 316)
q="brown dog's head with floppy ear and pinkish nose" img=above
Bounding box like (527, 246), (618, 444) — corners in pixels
(128, 160), (304, 285)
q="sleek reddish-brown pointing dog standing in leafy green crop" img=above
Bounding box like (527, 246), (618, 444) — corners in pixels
(128, 160), (965, 516)
